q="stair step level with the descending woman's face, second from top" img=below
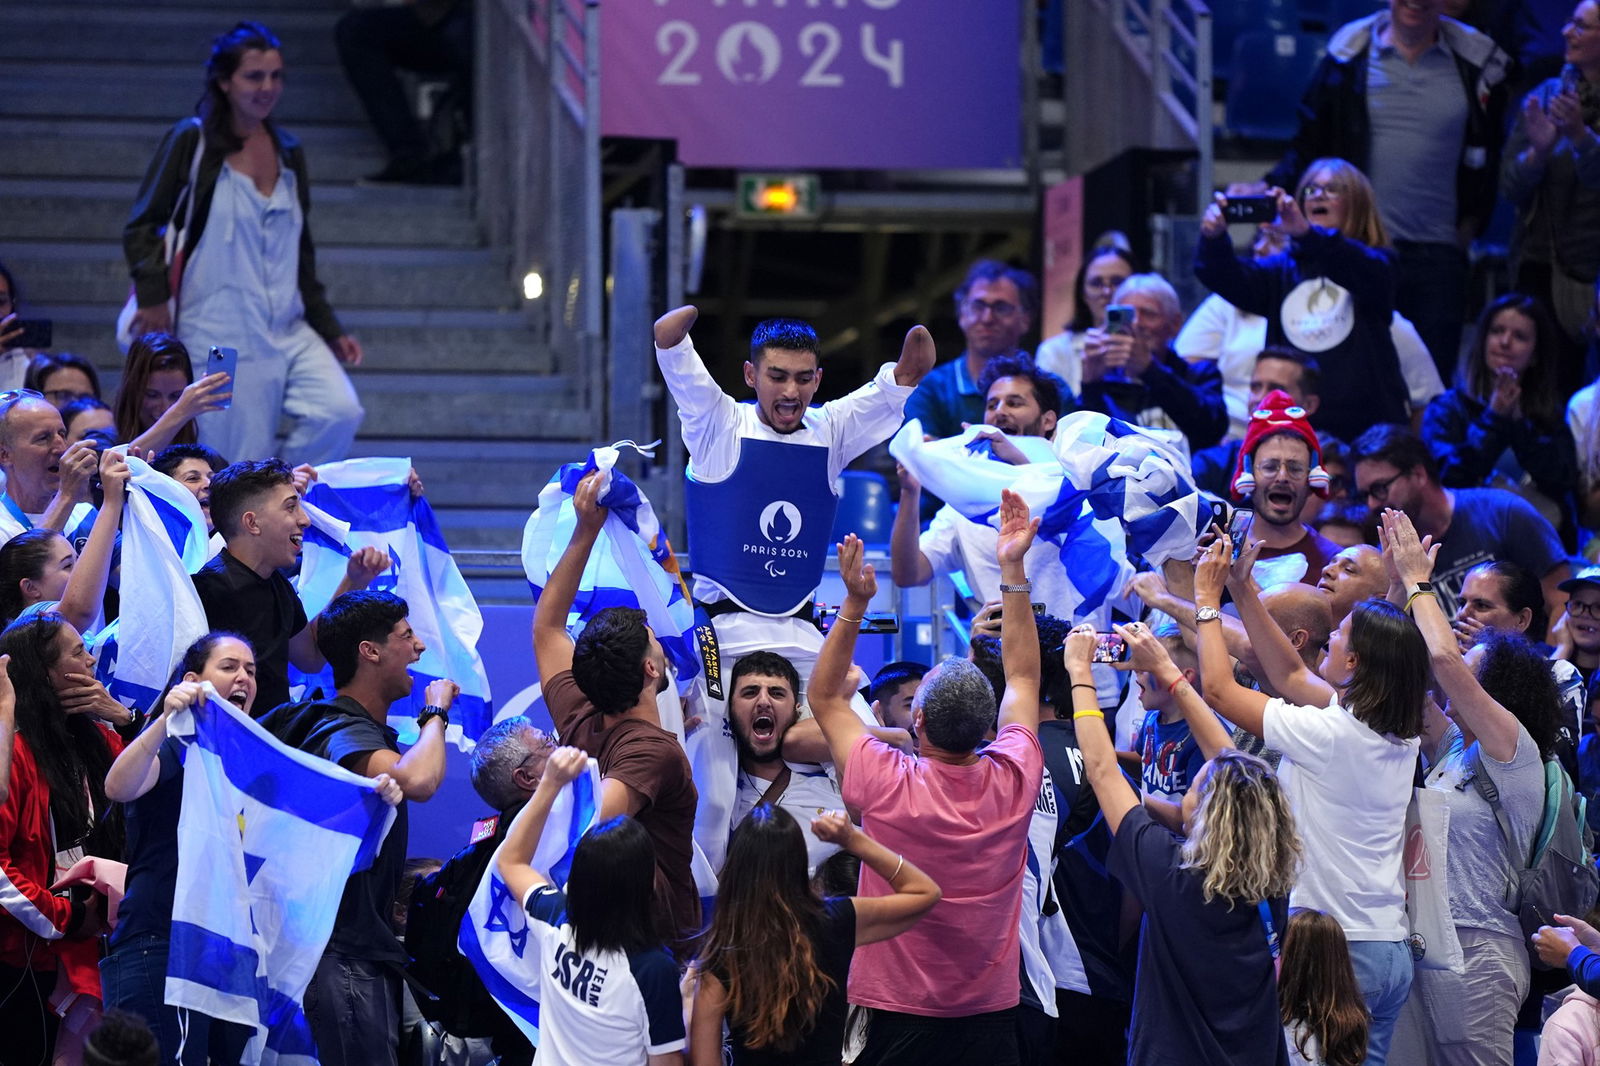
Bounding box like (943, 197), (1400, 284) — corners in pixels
(0, 59), (363, 130)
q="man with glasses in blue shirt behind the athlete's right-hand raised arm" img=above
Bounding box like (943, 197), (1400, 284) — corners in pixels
(906, 259), (1038, 439)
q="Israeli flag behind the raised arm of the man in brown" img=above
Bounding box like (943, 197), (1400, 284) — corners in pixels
(522, 440), (701, 685)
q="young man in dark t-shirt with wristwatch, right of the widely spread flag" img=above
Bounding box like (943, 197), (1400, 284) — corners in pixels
(261, 591), (461, 1066)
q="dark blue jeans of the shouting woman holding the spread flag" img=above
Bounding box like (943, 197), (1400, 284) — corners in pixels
(101, 936), (254, 1066)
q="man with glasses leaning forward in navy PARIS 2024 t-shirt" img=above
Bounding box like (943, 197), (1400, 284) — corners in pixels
(1350, 426), (1571, 624)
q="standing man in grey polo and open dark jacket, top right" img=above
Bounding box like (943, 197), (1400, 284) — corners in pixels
(1266, 0), (1510, 381)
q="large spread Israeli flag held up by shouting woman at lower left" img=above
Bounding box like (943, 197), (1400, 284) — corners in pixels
(166, 685), (395, 1066)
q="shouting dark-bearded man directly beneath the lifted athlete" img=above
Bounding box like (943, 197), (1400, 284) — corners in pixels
(728, 651), (843, 874)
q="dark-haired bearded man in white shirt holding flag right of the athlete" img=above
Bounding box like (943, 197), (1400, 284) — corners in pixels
(890, 354), (1077, 618)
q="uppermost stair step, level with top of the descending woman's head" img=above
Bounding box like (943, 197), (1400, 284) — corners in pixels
(0, 7), (339, 66)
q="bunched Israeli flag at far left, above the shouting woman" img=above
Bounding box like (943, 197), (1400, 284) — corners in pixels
(90, 456), (211, 711)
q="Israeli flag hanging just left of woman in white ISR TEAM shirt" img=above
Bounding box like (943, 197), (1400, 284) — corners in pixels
(456, 759), (600, 1047)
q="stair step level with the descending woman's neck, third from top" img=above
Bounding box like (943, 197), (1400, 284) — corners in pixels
(0, 119), (384, 190)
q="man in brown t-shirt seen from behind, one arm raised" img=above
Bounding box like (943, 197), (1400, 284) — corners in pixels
(533, 474), (701, 944)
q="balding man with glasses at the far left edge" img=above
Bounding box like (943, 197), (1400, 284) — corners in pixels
(0, 391), (99, 549)
